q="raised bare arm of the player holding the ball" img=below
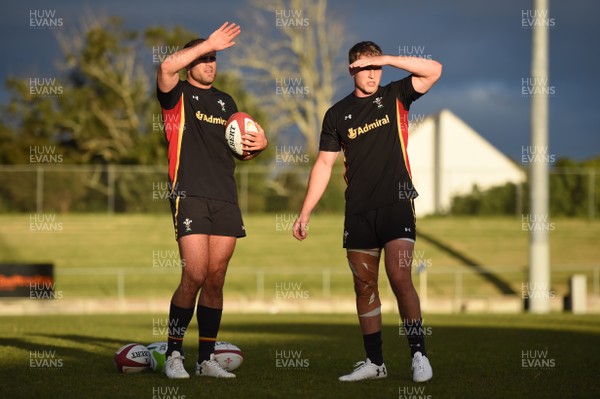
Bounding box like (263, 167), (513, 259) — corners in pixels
(157, 22), (240, 93)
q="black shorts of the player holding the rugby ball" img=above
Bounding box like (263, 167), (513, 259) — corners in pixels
(171, 197), (246, 240)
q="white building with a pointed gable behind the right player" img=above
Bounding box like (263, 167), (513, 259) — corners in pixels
(408, 110), (527, 215)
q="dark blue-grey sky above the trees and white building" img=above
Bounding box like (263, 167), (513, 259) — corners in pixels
(0, 0), (600, 160)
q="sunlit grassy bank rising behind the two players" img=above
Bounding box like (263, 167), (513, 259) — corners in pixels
(0, 214), (600, 299)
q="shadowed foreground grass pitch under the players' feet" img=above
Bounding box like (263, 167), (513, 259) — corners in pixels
(0, 313), (600, 399)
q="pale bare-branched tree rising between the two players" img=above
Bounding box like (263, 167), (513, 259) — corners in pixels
(232, 0), (348, 156)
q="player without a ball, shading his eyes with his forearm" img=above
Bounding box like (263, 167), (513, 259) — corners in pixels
(293, 42), (442, 382)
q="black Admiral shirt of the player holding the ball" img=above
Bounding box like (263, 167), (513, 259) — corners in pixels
(157, 80), (237, 203)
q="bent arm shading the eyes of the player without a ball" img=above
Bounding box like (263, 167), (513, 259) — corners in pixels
(350, 55), (442, 93)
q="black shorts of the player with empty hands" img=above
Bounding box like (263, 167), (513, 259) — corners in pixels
(344, 200), (416, 249)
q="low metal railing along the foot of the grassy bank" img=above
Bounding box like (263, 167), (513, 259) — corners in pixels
(56, 264), (600, 311)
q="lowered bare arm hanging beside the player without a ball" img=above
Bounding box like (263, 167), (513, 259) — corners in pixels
(292, 151), (339, 241)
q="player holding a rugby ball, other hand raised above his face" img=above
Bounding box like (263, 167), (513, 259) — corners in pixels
(157, 22), (268, 378)
